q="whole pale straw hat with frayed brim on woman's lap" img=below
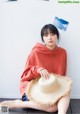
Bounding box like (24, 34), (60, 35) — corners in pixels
(26, 74), (72, 105)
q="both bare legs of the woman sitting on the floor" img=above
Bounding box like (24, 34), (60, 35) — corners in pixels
(0, 94), (70, 114)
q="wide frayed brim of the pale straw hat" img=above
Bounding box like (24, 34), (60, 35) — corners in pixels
(26, 75), (73, 105)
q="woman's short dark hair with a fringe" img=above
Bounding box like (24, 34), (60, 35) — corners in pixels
(41, 24), (59, 42)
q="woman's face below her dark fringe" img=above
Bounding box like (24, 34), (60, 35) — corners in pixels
(43, 32), (58, 48)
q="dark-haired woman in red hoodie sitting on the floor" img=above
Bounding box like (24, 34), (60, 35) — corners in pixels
(2, 24), (70, 114)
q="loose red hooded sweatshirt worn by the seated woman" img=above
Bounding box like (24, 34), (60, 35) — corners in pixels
(20, 43), (67, 95)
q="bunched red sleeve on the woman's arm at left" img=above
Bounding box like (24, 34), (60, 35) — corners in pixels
(21, 54), (43, 82)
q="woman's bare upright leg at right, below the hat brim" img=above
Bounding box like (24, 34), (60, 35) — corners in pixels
(58, 94), (70, 114)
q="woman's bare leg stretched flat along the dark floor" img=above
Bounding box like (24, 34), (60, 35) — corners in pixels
(0, 100), (57, 112)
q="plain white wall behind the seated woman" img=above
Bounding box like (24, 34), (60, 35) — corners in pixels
(0, 0), (80, 98)
